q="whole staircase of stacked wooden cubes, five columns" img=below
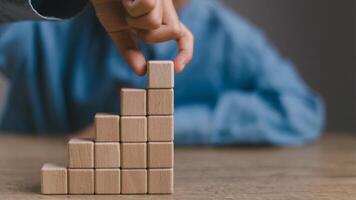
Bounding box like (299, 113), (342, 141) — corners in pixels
(41, 61), (174, 194)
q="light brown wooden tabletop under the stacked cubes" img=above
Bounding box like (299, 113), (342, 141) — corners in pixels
(0, 133), (356, 200)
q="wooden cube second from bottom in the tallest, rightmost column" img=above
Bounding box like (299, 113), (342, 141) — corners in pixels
(148, 142), (174, 168)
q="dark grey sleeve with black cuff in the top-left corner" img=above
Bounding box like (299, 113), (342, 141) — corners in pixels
(0, 0), (87, 24)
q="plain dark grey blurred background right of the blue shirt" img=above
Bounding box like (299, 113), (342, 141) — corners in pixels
(222, 0), (356, 131)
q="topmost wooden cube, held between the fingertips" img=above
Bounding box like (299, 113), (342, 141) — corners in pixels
(147, 61), (174, 89)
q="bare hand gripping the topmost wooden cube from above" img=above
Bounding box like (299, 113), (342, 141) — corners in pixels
(92, 0), (194, 75)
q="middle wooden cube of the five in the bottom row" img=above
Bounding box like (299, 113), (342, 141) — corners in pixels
(95, 169), (121, 194)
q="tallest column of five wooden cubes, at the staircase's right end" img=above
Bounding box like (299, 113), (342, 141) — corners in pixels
(147, 61), (174, 194)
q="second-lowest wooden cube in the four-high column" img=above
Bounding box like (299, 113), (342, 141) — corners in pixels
(121, 143), (147, 169)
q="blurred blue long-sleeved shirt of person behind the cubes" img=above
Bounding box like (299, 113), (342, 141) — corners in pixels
(0, 0), (324, 145)
